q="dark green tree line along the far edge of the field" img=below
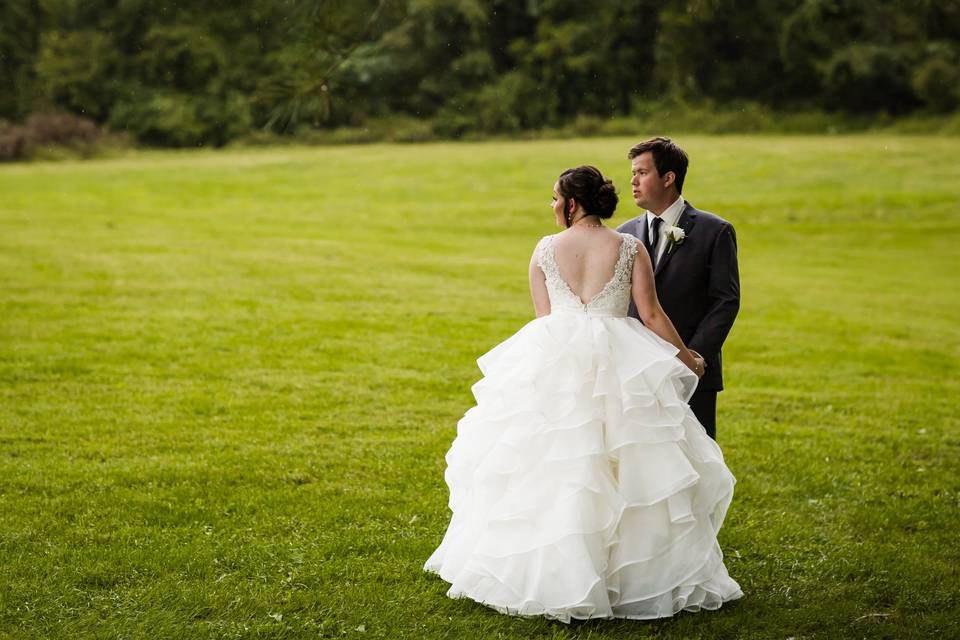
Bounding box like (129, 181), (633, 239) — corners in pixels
(0, 0), (960, 146)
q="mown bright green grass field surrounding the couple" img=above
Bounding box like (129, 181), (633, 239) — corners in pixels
(0, 136), (960, 640)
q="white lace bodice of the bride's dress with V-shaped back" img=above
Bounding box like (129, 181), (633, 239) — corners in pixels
(536, 233), (637, 317)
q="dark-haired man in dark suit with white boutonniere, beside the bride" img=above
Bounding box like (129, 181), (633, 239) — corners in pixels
(618, 138), (740, 440)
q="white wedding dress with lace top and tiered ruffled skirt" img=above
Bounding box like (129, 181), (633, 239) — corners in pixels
(424, 234), (742, 622)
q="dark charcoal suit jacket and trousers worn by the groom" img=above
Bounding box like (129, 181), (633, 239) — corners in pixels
(617, 201), (740, 439)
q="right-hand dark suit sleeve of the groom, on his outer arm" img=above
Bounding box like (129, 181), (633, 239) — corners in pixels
(687, 224), (740, 357)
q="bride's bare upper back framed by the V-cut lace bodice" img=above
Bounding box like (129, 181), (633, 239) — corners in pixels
(553, 227), (623, 303)
